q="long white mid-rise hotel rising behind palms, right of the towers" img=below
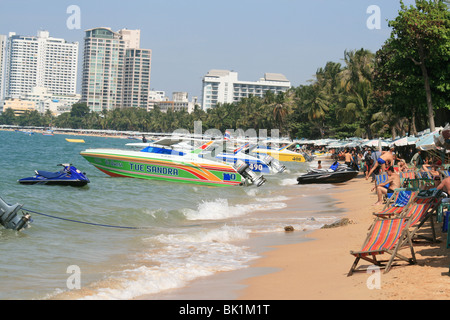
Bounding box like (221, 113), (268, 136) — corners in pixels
(202, 70), (291, 111)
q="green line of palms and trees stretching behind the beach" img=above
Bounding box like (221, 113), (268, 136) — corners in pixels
(0, 0), (450, 138)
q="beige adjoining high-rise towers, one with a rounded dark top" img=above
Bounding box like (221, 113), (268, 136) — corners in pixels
(81, 28), (151, 111)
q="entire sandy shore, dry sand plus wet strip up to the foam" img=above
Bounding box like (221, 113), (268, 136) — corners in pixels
(135, 174), (450, 301)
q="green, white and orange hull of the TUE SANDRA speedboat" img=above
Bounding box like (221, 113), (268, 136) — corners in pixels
(80, 149), (242, 186)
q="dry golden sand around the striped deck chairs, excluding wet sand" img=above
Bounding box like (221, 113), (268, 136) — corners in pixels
(239, 175), (450, 300)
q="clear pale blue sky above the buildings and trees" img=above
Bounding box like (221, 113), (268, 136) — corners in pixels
(0, 0), (414, 99)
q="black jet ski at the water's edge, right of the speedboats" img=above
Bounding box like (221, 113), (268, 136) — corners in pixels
(297, 161), (358, 184)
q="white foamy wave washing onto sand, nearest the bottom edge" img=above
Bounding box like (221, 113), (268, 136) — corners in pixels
(79, 226), (257, 300)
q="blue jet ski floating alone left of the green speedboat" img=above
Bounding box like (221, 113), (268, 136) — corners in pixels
(18, 163), (90, 187)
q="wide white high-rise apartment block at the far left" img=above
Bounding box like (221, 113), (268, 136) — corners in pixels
(0, 31), (78, 98)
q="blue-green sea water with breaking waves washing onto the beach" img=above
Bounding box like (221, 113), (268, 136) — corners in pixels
(0, 131), (341, 300)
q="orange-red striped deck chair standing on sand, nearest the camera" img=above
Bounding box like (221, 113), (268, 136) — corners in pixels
(347, 218), (416, 276)
